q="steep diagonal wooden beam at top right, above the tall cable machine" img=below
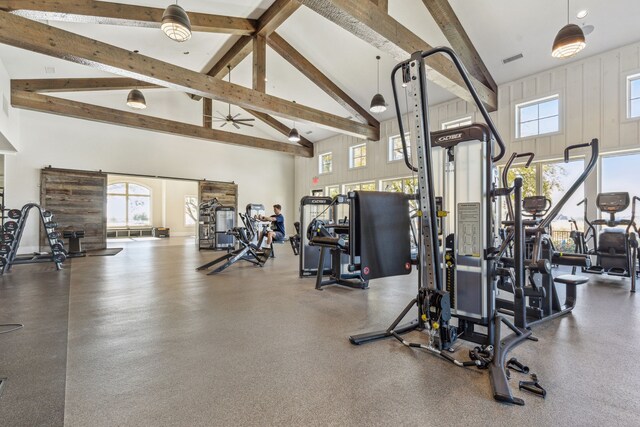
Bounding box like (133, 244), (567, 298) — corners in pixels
(422, 0), (498, 91)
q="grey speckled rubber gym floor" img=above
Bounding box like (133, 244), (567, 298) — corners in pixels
(0, 237), (640, 426)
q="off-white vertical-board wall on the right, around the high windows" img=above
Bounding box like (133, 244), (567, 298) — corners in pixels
(295, 42), (640, 205)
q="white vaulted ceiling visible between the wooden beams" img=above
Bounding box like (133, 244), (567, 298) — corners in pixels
(0, 0), (640, 141)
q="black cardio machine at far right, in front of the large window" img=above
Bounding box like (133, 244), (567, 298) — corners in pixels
(571, 192), (640, 292)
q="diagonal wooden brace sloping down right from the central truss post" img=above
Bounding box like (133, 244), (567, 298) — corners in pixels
(267, 32), (380, 127)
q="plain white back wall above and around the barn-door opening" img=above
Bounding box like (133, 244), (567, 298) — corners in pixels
(6, 107), (295, 251)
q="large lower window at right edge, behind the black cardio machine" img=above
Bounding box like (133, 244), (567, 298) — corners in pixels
(600, 153), (640, 219)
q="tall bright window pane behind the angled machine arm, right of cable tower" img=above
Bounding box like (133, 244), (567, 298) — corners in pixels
(542, 160), (584, 252)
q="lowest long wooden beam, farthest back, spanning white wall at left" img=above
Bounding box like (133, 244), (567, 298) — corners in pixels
(11, 90), (313, 157)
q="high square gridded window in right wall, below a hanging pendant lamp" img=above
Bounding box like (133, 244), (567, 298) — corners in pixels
(516, 95), (560, 138)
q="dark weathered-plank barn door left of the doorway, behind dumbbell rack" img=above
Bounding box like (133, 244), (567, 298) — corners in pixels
(40, 168), (107, 250)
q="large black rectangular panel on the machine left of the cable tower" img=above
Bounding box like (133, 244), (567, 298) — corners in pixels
(349, 191), (412, 280)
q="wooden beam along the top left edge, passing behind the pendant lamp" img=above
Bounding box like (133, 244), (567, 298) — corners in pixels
(0, 0), (257, 35)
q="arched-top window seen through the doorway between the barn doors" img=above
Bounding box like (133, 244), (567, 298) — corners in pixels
(107, 182), (151, 227)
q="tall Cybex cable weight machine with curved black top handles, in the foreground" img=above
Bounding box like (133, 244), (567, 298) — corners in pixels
(349, 47), (556, 405)
